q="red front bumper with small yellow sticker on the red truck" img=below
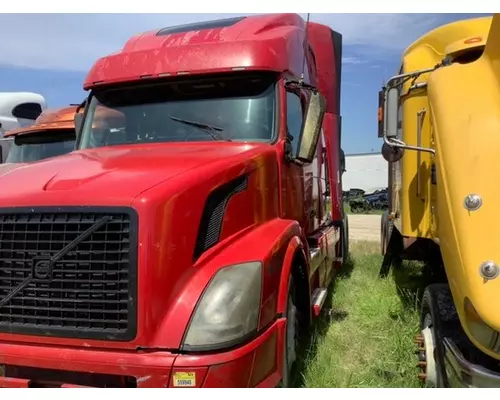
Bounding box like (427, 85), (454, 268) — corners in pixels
(0, 319), (285, 388)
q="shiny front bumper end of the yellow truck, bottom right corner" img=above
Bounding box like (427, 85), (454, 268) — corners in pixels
(443, 338), (500, 388)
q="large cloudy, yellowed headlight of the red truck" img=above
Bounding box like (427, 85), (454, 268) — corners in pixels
(183, 262), (262, 350)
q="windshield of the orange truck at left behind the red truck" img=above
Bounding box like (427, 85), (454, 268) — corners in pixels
(5, 130), (75, 163)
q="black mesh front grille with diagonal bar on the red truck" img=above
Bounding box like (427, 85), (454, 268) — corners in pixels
(0, 207), (138, 340)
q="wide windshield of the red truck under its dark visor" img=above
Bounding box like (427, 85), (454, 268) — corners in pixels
(79, 74), (276, 149)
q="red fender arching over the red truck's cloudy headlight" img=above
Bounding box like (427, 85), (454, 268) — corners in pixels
(147, 218), (307, 349)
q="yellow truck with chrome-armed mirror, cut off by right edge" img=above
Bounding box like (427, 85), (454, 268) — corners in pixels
(378, 14), (500, 387)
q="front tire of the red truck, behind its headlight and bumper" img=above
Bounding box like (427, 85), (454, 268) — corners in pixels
(279, 276), (299, 388)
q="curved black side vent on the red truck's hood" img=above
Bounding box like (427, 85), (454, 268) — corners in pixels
(194, 175), (248, 260)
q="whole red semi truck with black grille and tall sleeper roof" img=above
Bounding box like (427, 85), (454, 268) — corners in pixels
(0, 14), (348, 387)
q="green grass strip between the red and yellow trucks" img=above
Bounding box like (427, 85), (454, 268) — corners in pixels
(296, 242), (423, 388)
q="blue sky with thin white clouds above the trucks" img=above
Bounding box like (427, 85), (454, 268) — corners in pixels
(0, 14), (492, 154)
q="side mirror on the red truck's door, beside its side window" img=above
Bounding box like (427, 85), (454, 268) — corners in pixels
(295, 92), (326, 163)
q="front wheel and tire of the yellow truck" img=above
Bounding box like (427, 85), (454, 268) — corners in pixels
(420, 284), (457, 388)
